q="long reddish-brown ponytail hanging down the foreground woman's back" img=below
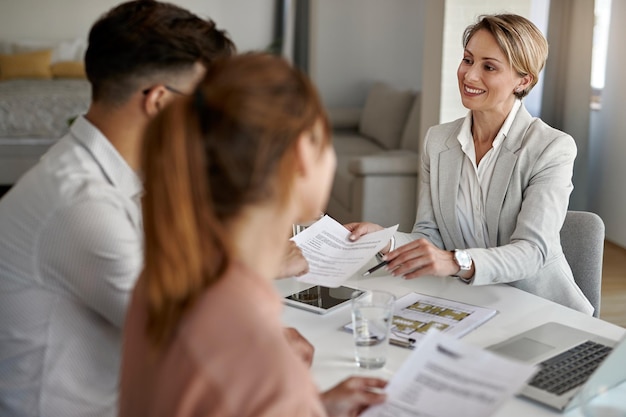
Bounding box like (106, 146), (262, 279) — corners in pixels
(142, 98), (228, 347)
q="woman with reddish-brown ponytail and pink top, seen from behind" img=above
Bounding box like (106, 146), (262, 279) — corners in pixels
(120, 54), (385, 417)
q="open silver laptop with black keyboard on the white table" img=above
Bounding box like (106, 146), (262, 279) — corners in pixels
(487, 322), (626, 411)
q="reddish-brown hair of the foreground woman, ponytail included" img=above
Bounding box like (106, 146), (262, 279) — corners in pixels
(143, 53), (330, 347)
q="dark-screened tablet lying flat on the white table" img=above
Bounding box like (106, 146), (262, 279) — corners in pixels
(285, 285), (363, 314)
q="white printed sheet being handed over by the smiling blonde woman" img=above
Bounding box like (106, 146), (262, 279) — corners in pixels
(291, 216), (398, 288)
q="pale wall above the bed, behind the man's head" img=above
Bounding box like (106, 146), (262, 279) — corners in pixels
(0, 0), (274, 50)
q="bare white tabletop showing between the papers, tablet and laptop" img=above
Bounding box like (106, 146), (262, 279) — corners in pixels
(276, 262), (626, 417)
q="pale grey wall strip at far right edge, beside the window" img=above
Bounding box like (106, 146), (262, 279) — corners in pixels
(589, 0), (626, 247)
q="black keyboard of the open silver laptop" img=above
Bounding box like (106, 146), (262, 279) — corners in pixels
(529, 341), (612, 395)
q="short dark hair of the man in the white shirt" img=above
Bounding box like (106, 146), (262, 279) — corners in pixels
(85, 0), (235, 105)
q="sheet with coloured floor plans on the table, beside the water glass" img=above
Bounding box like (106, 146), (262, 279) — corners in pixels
(344, 292), (497, 348)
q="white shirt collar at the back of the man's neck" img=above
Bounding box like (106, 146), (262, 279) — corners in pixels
(70, 116), (143, 197)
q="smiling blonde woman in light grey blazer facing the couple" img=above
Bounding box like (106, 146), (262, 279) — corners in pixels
(347, 14), (593, 314)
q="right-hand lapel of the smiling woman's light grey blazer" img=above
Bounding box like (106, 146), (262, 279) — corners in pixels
(485, 104), (532, 246)
